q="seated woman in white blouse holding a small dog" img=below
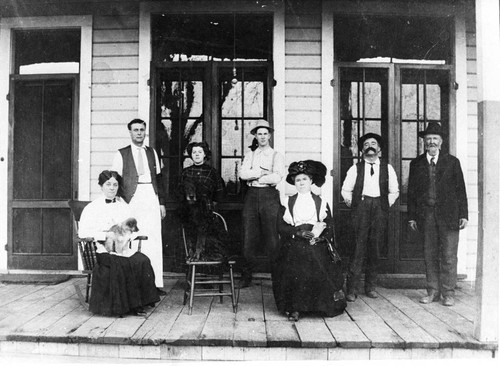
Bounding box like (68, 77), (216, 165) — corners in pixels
(78, 170), (160, 316)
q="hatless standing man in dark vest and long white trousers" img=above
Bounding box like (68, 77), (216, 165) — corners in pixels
(112, 119), (166, 295)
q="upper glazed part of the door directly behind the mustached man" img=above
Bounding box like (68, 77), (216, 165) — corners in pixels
(339, 68), (388, 192)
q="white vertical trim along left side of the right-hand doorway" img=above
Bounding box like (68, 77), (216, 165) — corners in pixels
(321, 9), (335, 207)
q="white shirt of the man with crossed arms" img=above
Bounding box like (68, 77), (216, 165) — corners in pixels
(240, 146), (285, 187)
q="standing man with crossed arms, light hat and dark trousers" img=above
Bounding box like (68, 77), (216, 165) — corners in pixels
(240, 120), (286, 287)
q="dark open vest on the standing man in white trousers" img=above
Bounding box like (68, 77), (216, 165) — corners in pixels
(118, 145), (158, 203)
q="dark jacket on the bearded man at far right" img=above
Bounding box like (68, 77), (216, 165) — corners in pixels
(408, 152), (469, 230)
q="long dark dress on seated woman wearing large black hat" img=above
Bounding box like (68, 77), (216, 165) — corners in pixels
(272, 194), (346, 317)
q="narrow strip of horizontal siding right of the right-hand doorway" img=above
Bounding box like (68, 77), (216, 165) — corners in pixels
(464, 2), (479, 280)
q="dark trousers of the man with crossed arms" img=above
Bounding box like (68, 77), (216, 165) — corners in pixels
(242, 187), (281, 277)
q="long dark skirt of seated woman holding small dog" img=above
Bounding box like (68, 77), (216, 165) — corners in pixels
(89, 252), (160, 316)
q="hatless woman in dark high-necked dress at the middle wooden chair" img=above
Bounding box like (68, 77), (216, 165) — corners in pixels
(179, 142), (227, 261)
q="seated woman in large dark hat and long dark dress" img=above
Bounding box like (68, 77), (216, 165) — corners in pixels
(272, 160), (346, 321)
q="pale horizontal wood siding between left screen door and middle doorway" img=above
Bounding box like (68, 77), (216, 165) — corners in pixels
(90, 12), (139, 198)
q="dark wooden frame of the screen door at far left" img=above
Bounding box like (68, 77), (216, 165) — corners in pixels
(7, 74), (80, 269)
